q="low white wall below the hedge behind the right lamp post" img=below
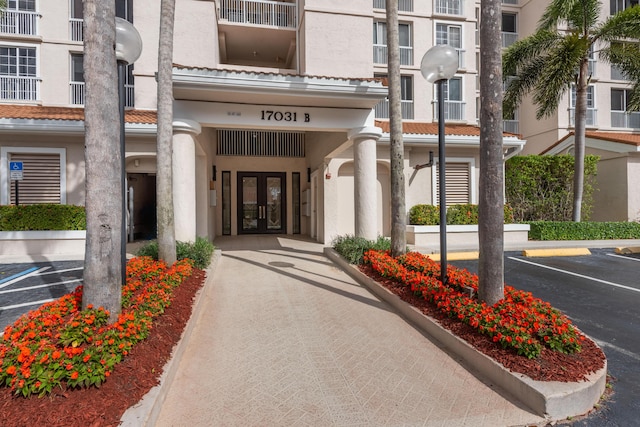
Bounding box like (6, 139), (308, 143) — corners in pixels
(407, 224), (530, 246)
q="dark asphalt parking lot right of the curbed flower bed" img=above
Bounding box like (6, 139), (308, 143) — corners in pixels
(450, 249), (640, 427)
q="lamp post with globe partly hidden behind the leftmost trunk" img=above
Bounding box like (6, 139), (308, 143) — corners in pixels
(115, 17), (142, 285)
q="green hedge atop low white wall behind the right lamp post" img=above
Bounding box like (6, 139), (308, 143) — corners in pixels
(409, 203), (513, 225)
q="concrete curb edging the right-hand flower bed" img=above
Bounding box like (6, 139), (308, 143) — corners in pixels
(324, 247), (607, 420)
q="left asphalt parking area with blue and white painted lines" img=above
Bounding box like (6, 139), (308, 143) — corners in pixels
(0, 261), (84, 333)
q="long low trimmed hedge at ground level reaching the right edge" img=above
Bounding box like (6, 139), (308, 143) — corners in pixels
(529, 221), (640, 240)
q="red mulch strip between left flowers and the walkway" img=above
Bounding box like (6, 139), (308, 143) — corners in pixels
(0, 270), (205, 427)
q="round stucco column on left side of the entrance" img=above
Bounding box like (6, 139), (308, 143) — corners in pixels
(172, 119), (202, 242)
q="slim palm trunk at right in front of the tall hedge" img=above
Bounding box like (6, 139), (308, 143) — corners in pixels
(572, 59), (589, 222)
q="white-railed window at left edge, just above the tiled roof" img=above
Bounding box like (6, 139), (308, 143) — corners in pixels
(0, 46), (39, 101)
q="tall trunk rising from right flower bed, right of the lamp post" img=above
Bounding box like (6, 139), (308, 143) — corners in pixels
(478, 0), (504, 305)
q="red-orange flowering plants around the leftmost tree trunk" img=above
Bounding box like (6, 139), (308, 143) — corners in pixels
(0, 257), (193, 397)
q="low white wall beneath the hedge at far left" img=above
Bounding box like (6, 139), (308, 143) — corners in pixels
(0, 230), (87, 256)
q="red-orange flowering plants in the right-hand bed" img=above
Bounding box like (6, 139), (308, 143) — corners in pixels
(364, 250), (585, 359)
